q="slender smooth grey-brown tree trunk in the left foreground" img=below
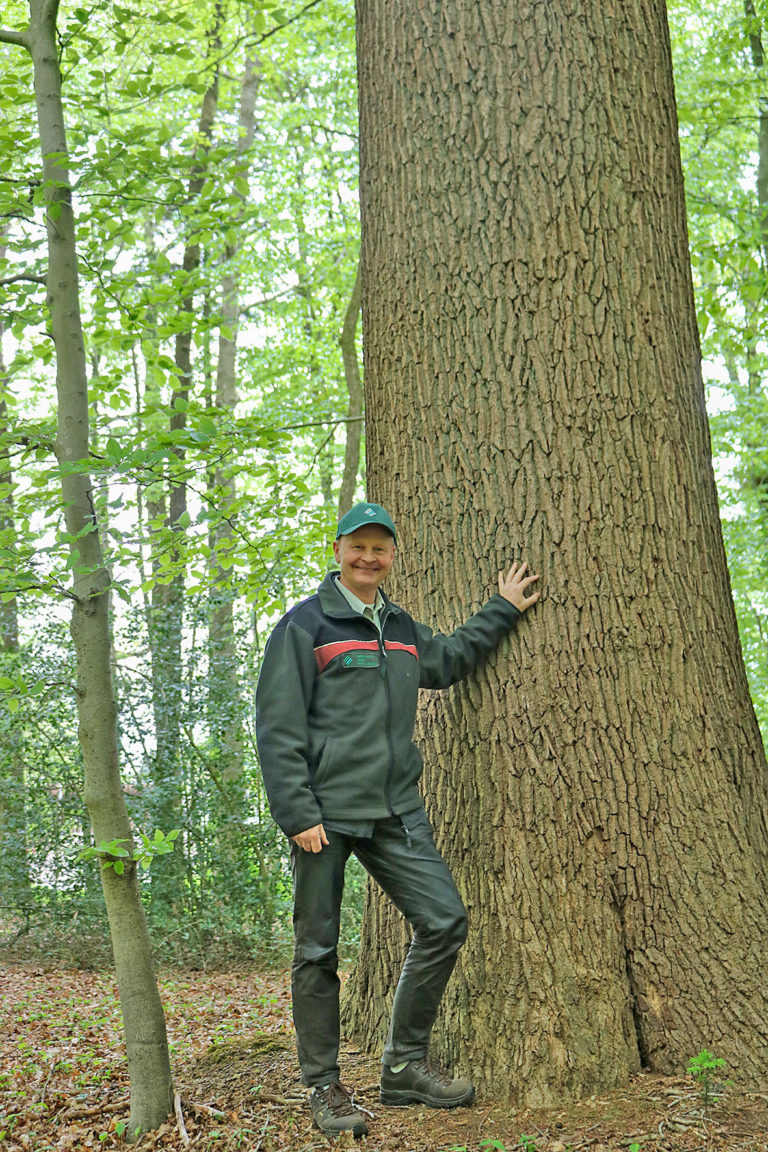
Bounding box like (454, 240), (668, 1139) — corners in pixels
(0, 0), (173, 1130)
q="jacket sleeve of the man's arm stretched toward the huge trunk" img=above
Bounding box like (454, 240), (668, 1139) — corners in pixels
(416, 594), (522, 688)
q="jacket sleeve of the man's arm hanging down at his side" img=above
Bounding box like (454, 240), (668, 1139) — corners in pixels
(256, 621), (322, 836)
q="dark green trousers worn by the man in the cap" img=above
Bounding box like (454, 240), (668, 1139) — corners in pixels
(291, 813), (466, 1085)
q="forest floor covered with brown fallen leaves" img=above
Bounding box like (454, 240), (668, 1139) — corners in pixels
(0, 967), (768, 1152)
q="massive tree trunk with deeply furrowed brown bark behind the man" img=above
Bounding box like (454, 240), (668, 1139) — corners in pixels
(345, 0), (768, 1104)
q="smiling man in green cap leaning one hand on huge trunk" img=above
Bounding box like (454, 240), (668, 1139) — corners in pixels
(256, 503), (539, 1136)
